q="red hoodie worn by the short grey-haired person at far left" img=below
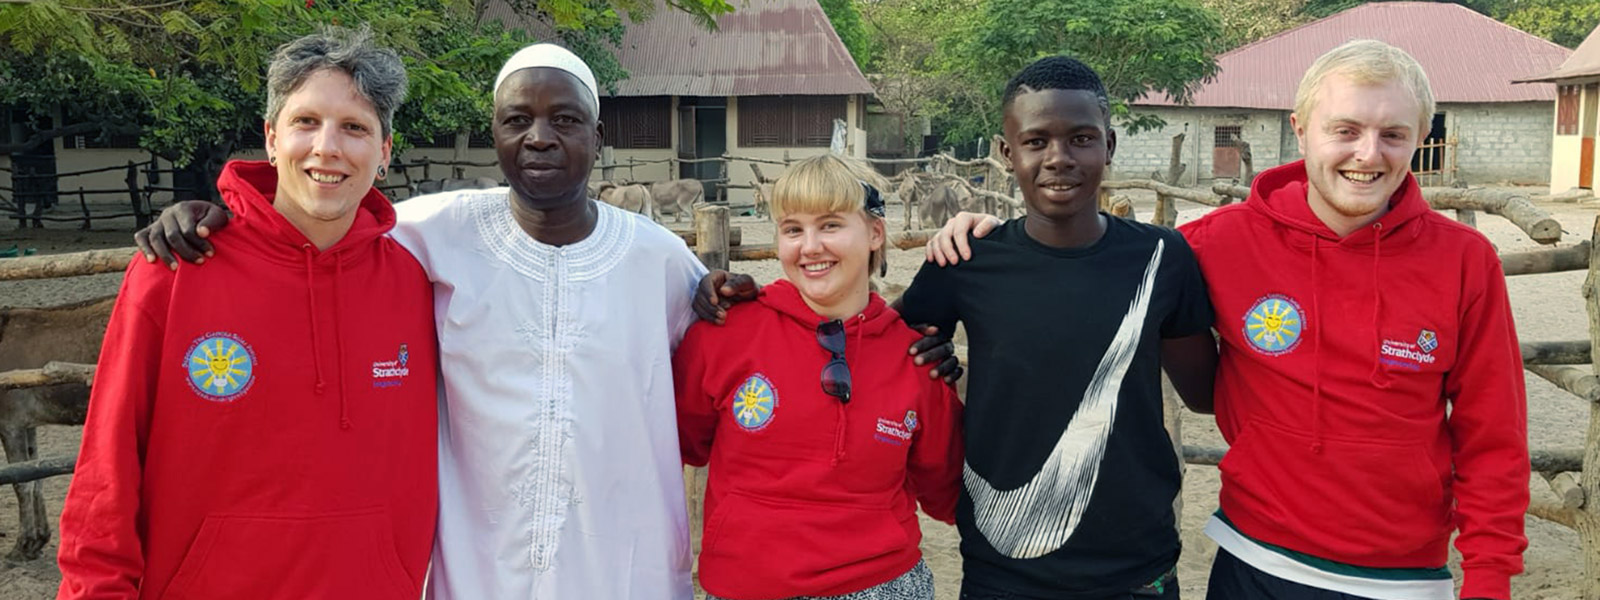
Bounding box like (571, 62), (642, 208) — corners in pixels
(58, 162), (438, 600)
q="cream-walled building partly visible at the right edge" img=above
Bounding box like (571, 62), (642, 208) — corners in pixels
(1518, 27), (1600, 194)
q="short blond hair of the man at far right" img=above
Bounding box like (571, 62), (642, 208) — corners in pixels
(1294, 40), (1434, 139)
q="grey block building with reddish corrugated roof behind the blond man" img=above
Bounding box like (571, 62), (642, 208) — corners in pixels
(1115, 2), (1571, 184)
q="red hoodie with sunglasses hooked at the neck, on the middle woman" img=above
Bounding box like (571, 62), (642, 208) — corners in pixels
(672, 280), (963, 600)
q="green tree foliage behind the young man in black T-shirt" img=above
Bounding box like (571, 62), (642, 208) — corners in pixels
(939, 0), (1224, 139)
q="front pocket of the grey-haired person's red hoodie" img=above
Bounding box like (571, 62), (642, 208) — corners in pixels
(162, 509), (421, 600)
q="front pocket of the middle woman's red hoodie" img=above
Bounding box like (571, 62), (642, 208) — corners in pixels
(699, 491), (917, 597)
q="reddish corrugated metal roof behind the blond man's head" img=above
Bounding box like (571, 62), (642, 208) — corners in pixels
(1134, 2), (1571, 110)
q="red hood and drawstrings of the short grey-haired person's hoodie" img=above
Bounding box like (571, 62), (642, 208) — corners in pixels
(216, 160), (395, 429)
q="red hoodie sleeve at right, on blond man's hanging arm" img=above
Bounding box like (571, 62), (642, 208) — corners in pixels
(1445, 245), (1528, 598)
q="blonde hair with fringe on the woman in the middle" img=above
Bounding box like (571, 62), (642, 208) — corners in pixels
(771, 154), (888, 272)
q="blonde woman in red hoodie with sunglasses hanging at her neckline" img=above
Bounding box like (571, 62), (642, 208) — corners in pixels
(674, 155), (962, 600)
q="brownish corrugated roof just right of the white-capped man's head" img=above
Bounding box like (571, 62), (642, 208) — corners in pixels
(485, 0), (874, 96)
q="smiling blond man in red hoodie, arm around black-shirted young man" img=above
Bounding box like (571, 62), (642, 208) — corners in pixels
(930, 40), (1528, 600)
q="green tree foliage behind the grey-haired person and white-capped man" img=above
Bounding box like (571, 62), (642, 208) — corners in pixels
(0, 0), (731, 173)
